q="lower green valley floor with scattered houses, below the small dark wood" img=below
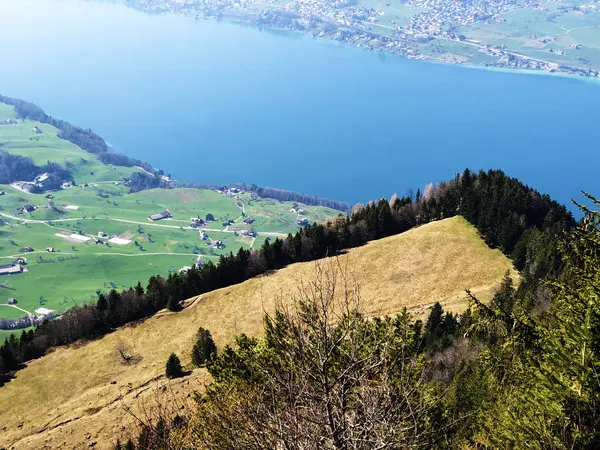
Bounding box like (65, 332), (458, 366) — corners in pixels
(0, 167), (339, 330)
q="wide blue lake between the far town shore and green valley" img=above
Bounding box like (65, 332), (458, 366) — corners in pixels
(0, 0), (600, 207)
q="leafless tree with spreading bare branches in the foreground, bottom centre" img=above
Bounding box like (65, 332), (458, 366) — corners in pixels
(189, 261), (438, 450)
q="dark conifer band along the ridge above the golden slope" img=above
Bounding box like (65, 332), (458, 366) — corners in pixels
(0, 170), (575, 375)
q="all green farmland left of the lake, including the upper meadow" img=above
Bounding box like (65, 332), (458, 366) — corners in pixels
(0, 104), (339, 318)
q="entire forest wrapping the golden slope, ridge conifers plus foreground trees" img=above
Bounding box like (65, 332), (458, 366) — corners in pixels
(0, 170), (584, 448)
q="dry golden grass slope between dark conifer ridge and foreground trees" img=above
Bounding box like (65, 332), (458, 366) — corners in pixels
(0, 217), (517, 449)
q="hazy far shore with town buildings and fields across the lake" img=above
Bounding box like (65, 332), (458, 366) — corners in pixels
(119, 0), (600, 78)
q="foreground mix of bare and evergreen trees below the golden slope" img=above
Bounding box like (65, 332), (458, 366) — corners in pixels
(115, 192), (600, 449)
